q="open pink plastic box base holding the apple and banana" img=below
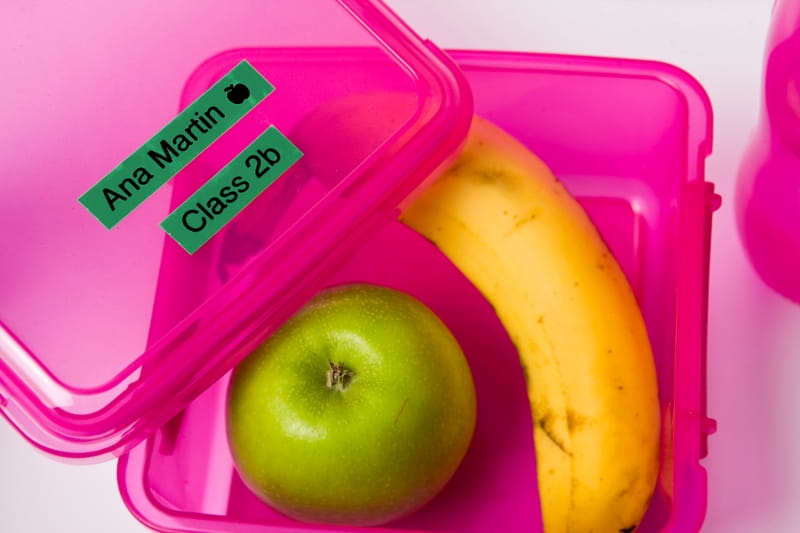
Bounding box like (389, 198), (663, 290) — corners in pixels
(119, 49), (719, 533)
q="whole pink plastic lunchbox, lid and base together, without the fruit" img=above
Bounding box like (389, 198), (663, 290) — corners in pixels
(0, 0), (720, 533)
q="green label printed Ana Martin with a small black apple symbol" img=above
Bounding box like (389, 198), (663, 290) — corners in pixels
(78, 61), (274, 229)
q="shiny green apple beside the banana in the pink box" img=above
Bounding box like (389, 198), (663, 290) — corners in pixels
(227, 284), (476, 525)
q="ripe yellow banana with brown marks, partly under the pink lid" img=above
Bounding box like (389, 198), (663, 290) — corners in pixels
(400, 117), (660, 533)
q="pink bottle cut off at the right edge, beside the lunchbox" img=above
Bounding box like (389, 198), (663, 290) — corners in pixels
(736, 0), (800, 303)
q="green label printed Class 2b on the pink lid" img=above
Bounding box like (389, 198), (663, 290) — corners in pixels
(161, 126), (303, 254)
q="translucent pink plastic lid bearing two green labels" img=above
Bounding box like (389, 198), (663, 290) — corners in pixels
(0, 0), (472, 459)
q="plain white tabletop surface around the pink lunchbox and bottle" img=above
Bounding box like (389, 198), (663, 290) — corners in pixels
(0, 0), (800, 533)
